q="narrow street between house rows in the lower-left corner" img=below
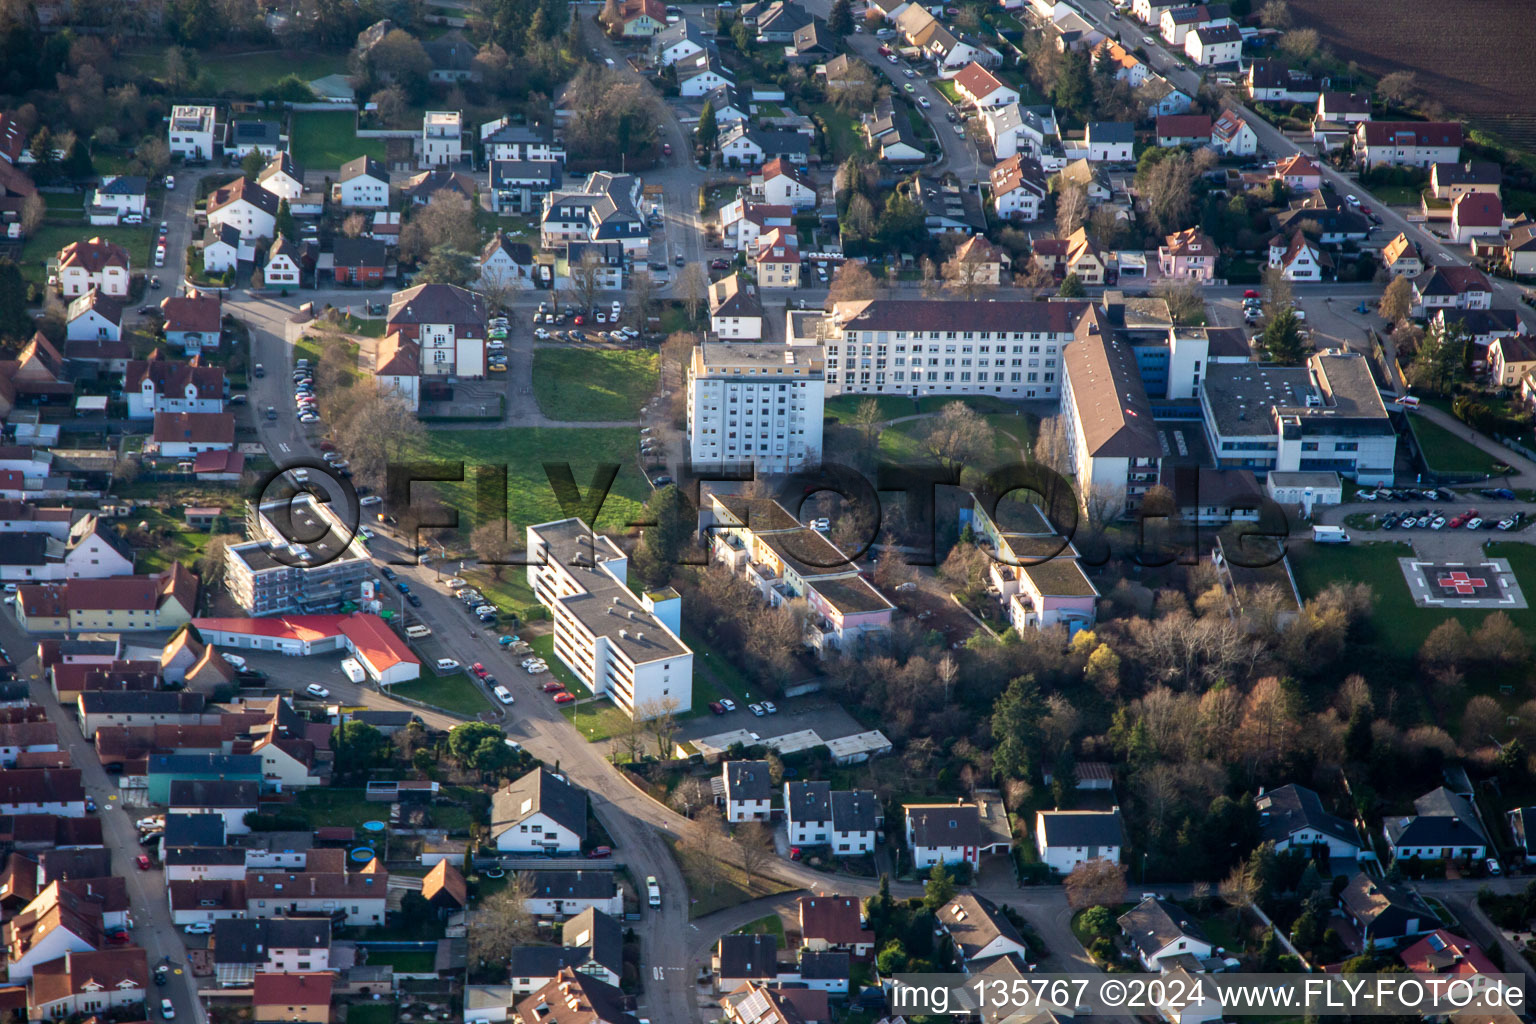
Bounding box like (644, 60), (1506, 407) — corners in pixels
(0, 611), (207, 1024)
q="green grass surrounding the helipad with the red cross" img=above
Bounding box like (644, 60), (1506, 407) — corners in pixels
(1289, 540), (1536, 660)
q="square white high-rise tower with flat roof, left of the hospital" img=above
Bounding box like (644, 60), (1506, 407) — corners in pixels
(688, 341), (826, 473)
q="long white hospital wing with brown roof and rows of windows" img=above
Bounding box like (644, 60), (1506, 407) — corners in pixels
(790, 299), (1087, 399)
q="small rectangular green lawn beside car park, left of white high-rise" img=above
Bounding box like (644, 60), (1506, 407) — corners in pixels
(533, 348), (659, 421)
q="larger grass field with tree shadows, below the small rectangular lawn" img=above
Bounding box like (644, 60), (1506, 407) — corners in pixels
(413, 427), (650, 534)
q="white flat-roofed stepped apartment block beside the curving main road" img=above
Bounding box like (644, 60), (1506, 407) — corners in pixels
(527, 519), (693, 718)
